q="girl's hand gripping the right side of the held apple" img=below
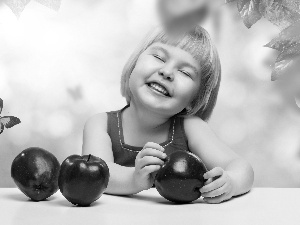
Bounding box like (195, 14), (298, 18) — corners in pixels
(200, 167), (235, 203)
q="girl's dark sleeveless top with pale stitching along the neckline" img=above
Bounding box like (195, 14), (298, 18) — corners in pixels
(107, 105), (189, 167)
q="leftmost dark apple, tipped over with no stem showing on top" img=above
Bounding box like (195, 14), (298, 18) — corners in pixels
(11, 147), (60, 201)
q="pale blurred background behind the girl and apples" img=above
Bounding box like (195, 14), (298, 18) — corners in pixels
(0, 0), (300, 187)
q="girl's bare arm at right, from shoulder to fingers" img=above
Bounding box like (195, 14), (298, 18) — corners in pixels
(184, 117), (254, 203)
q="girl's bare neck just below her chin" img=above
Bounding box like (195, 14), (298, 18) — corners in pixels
(123, 102), (170, 132)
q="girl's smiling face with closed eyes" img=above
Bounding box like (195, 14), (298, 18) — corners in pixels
(129, 43), (200, 116)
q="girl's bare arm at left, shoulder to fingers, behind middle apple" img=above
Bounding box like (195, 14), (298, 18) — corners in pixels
(82, 113), (166, 195)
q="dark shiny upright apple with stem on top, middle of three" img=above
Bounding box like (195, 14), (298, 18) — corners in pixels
(58, 154), (109, 206)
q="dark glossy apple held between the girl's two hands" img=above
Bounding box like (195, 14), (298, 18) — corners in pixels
(154, 151), (207, 203)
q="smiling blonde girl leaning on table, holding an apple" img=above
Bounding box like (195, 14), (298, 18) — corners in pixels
(83, 26), (254, 203)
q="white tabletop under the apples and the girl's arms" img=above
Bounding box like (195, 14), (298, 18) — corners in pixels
(0, 188), (300, 225)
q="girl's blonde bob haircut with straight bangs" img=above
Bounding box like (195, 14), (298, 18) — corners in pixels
(121, 26), (221, 121)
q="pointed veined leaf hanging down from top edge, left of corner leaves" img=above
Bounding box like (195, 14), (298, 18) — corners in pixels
(237, 0), (262, 28)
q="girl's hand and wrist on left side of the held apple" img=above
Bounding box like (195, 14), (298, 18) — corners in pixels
(134, 142), (167, 191)
